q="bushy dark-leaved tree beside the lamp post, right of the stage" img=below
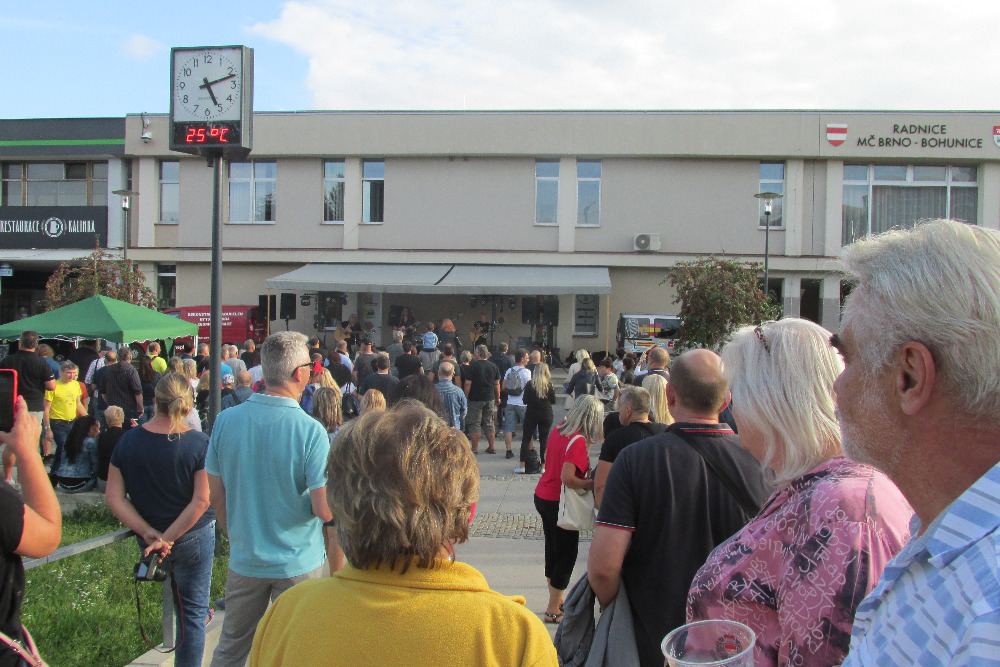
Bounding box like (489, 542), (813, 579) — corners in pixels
(660, 257), (781, 349)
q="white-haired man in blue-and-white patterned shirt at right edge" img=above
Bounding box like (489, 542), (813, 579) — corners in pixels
(831, 220), (1000, 665)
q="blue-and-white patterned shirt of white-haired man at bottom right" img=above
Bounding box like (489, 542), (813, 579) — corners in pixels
(844, 463), (1000, 667)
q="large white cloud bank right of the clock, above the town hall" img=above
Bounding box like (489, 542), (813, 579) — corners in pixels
(253, 0), (1000, 109)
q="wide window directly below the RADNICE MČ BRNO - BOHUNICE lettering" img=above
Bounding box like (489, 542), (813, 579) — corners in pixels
(842, 164), (979, 245)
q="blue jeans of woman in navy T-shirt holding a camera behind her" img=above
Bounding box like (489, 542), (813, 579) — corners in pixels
(137, 521), (215, 667)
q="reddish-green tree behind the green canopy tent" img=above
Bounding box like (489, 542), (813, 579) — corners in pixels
(43, 248), (156, 311)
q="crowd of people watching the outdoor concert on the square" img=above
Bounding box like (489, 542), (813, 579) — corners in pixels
(0, 221), (1000, 667)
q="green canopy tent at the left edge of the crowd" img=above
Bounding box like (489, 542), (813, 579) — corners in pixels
(0, 296), (198, 343)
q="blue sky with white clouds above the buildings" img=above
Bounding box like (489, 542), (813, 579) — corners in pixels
(0, 0), (1000, 118)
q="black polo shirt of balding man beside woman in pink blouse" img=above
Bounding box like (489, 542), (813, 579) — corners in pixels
(597, 423), (771, 667)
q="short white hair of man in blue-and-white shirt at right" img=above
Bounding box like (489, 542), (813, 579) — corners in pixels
(843, 220), (1000, 421)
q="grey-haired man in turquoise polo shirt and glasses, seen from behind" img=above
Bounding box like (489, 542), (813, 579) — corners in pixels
(205, 331), (333, 667)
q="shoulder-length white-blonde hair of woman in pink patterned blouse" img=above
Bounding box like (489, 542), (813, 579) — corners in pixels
(722, 318), (844, 486)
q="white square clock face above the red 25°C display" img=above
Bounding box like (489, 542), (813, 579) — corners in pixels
(171, 48), (243, 122)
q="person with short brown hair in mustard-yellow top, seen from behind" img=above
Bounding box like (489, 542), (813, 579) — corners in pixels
(249, 400), (557, 667)
